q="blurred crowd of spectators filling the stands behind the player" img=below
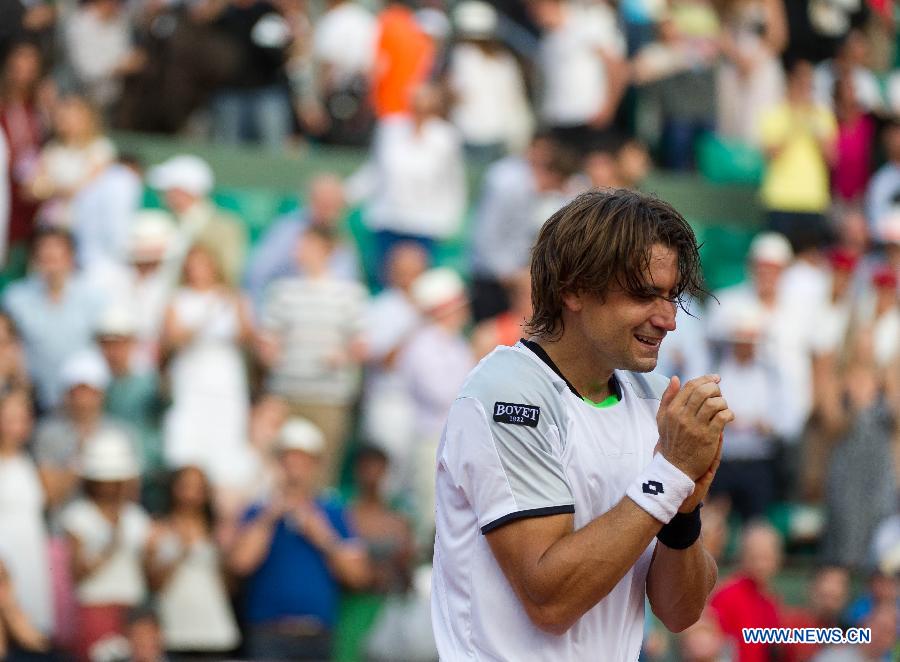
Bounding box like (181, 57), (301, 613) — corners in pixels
(0, 0), (900, 662)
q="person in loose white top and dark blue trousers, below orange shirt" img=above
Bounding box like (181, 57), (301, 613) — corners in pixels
(348, 85), (466, 272)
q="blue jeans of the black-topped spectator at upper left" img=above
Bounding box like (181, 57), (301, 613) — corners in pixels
(212, 85), (293, 149)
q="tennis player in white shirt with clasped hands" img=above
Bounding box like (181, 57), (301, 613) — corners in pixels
(432, 190), (733, 662)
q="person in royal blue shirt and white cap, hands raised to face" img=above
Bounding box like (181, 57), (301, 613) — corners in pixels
(228, 418), (371, 661)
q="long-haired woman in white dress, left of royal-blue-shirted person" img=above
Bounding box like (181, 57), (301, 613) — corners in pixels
(147, 467), (240, 657)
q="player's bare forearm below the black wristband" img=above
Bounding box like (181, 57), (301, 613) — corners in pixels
(647, 539), (719, 632)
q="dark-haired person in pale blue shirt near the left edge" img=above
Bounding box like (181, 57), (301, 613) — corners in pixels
(3, 228), (104, 411)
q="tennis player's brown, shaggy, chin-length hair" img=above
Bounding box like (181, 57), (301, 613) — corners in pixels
(525, 189), (706, 340)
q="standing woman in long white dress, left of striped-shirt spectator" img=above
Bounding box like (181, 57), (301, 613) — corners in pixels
(162, 246), (252, 488)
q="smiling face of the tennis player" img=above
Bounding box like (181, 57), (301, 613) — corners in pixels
(566, 244), (678, 372)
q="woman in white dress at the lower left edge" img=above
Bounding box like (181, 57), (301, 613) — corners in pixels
(0, 390), (53, 635)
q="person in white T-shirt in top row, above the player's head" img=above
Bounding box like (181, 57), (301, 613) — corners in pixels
(530, 0), (627, 149)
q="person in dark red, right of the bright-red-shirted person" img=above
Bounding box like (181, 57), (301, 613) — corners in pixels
(783, 566), (850, 662)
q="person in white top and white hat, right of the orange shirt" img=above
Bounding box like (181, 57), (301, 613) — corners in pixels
(447, 0), (534, 161)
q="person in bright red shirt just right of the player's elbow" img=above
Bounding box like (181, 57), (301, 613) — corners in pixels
(709, 523), (782, 662)
